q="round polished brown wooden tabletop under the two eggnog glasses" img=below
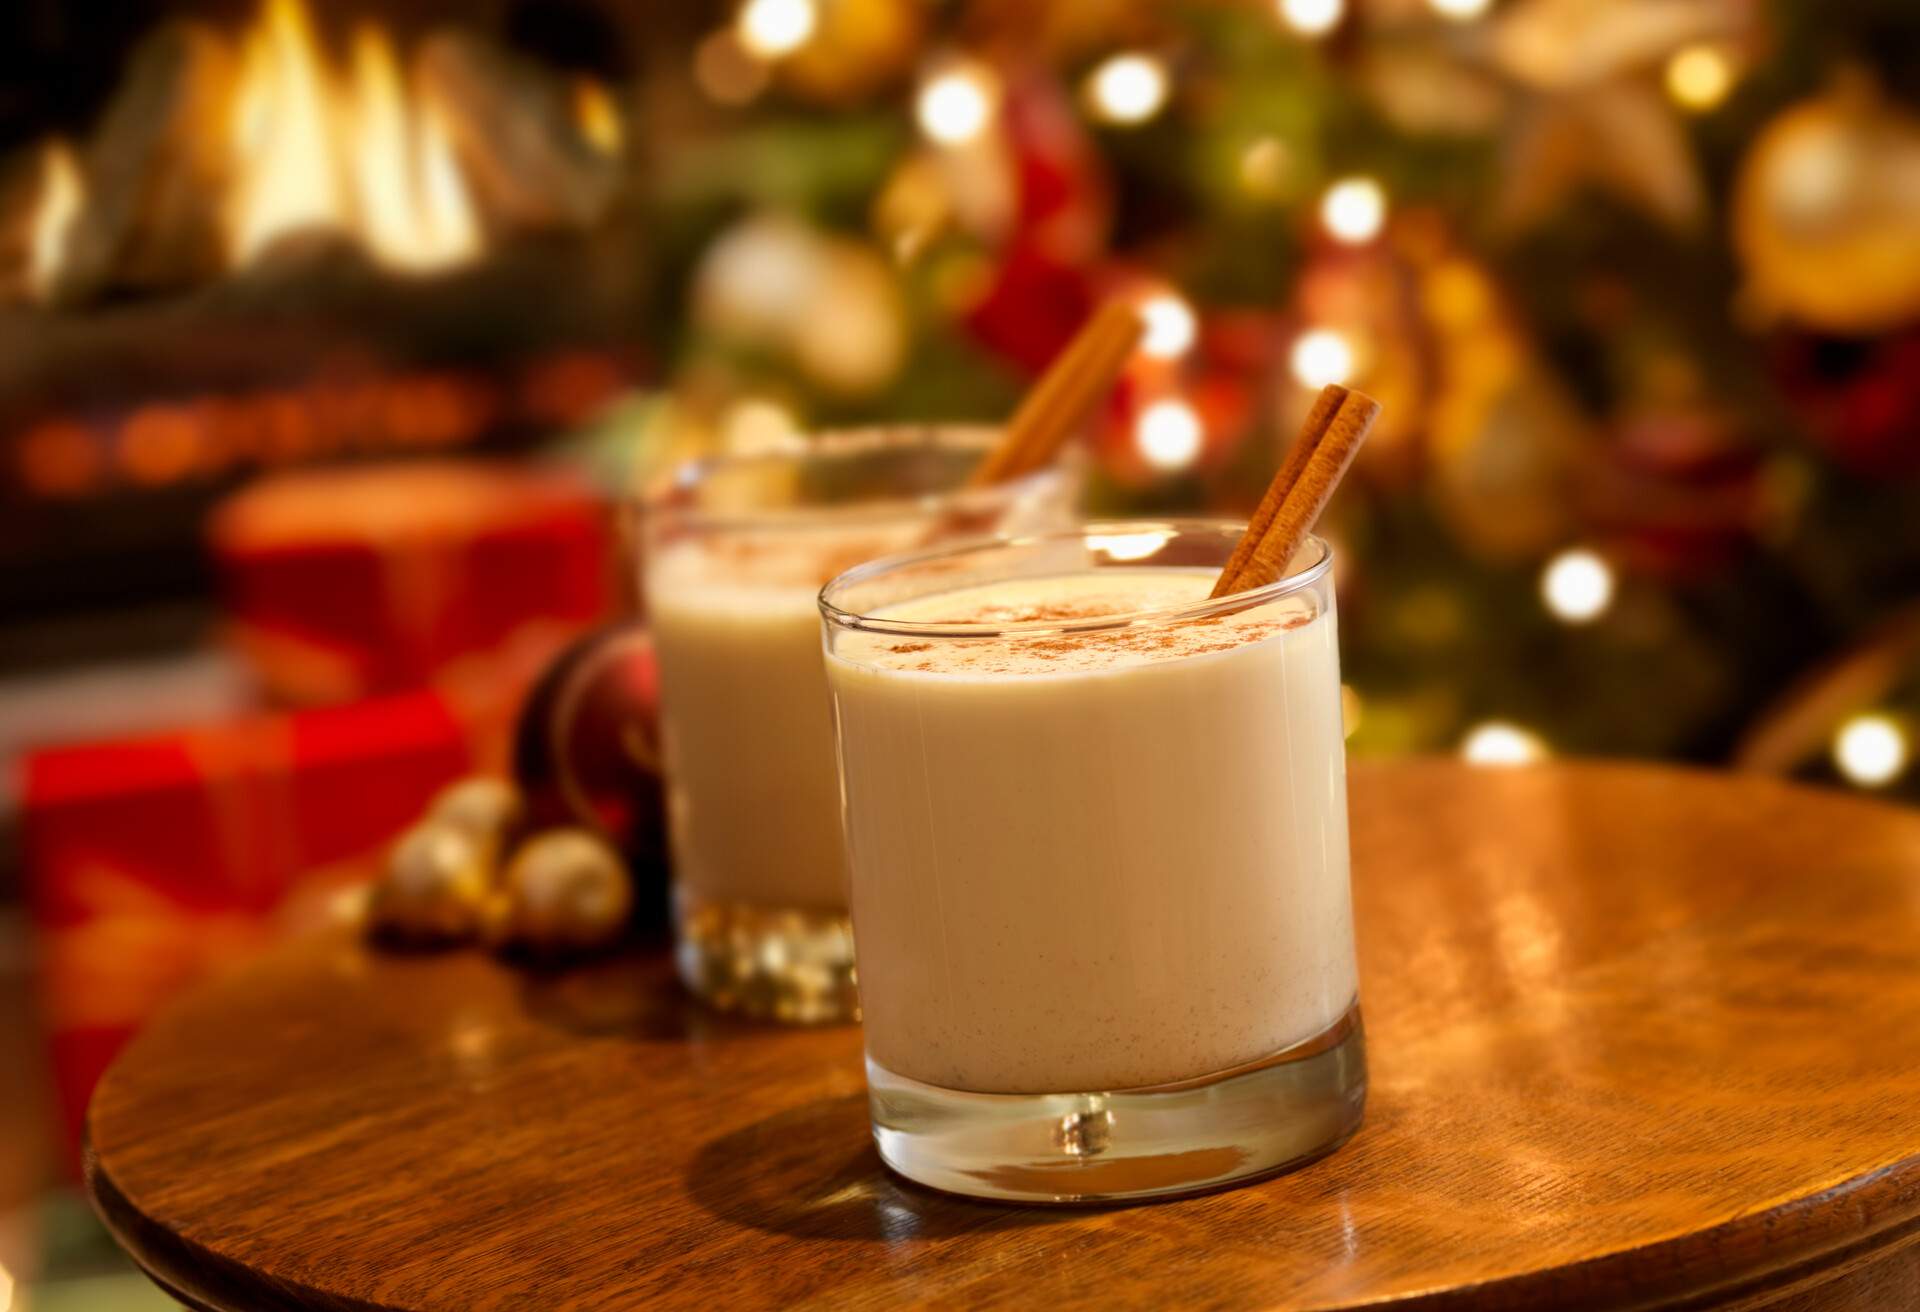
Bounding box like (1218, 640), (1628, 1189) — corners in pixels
(88, 763), (1920, 1312)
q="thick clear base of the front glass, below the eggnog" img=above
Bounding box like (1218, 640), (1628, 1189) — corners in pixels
(866, 1003), (1367, 1203)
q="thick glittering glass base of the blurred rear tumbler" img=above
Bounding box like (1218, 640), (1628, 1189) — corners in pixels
(674, 889), (860, 1024)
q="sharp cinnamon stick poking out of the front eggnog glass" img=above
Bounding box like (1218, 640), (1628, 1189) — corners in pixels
(1212, 386), (1380, 597)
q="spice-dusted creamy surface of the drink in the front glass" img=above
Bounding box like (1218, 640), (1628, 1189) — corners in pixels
(837, 567), (1315, 676)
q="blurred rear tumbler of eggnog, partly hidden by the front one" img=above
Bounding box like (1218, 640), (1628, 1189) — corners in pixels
(639, 426), (1081, 1022)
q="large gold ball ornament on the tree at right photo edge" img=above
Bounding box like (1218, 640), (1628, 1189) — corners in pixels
(1734, 85), (1920, 334)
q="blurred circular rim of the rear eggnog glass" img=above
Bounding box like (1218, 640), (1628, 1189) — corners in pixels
(634, 421), (1073, 532)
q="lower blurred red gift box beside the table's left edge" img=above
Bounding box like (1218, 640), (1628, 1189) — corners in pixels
(23, 693), (483, 1141)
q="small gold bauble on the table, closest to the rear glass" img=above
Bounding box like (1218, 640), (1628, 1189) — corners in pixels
(505, 830), (634, 953)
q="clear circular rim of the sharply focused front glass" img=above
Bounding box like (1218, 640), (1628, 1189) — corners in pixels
(818, 519), (1332, 638)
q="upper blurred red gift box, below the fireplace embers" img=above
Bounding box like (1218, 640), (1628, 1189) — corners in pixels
(207, 461), (612, 705)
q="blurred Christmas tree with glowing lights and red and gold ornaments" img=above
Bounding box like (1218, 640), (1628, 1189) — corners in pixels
(610, 0), (1920, 795)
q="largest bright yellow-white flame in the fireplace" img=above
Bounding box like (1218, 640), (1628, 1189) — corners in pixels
(228, 0), (482, 271)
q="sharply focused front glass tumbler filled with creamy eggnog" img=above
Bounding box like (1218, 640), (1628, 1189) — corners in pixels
(820, 521), (1367, 1203)
